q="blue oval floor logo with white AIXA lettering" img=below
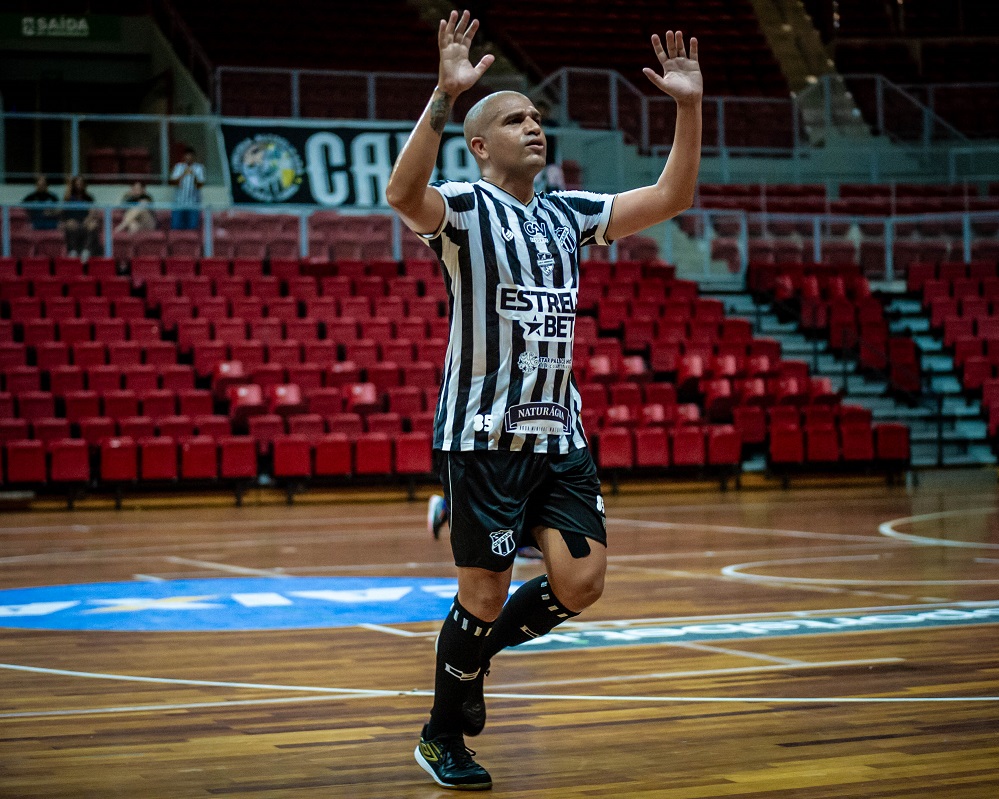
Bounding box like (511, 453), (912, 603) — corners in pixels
(0, 577), (458, 632)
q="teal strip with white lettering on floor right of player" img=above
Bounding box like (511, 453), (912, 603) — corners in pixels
(516, 603), (999, 652)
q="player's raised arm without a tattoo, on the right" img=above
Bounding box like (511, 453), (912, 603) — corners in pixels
(607, 31), (704, 239)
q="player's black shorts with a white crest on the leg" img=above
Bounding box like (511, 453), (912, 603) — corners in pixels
(434, 449), (607, 572)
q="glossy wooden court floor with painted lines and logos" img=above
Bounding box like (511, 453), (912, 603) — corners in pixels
(0, 475), (999, 799)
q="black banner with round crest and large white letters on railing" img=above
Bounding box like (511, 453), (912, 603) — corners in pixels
(222, 122), (479, 209)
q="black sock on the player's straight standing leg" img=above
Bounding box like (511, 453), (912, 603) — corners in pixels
(427, 597), (493, 738)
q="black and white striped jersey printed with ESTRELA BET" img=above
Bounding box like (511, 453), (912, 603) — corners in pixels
(426, 180), (614, 454)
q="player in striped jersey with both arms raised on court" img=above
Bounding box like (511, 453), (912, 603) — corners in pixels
(386, 11), (703, 790)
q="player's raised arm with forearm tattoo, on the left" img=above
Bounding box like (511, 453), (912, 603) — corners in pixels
(385, 11), (494, 233)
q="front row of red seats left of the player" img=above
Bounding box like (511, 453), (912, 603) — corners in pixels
(3, 433), (431, 487)
